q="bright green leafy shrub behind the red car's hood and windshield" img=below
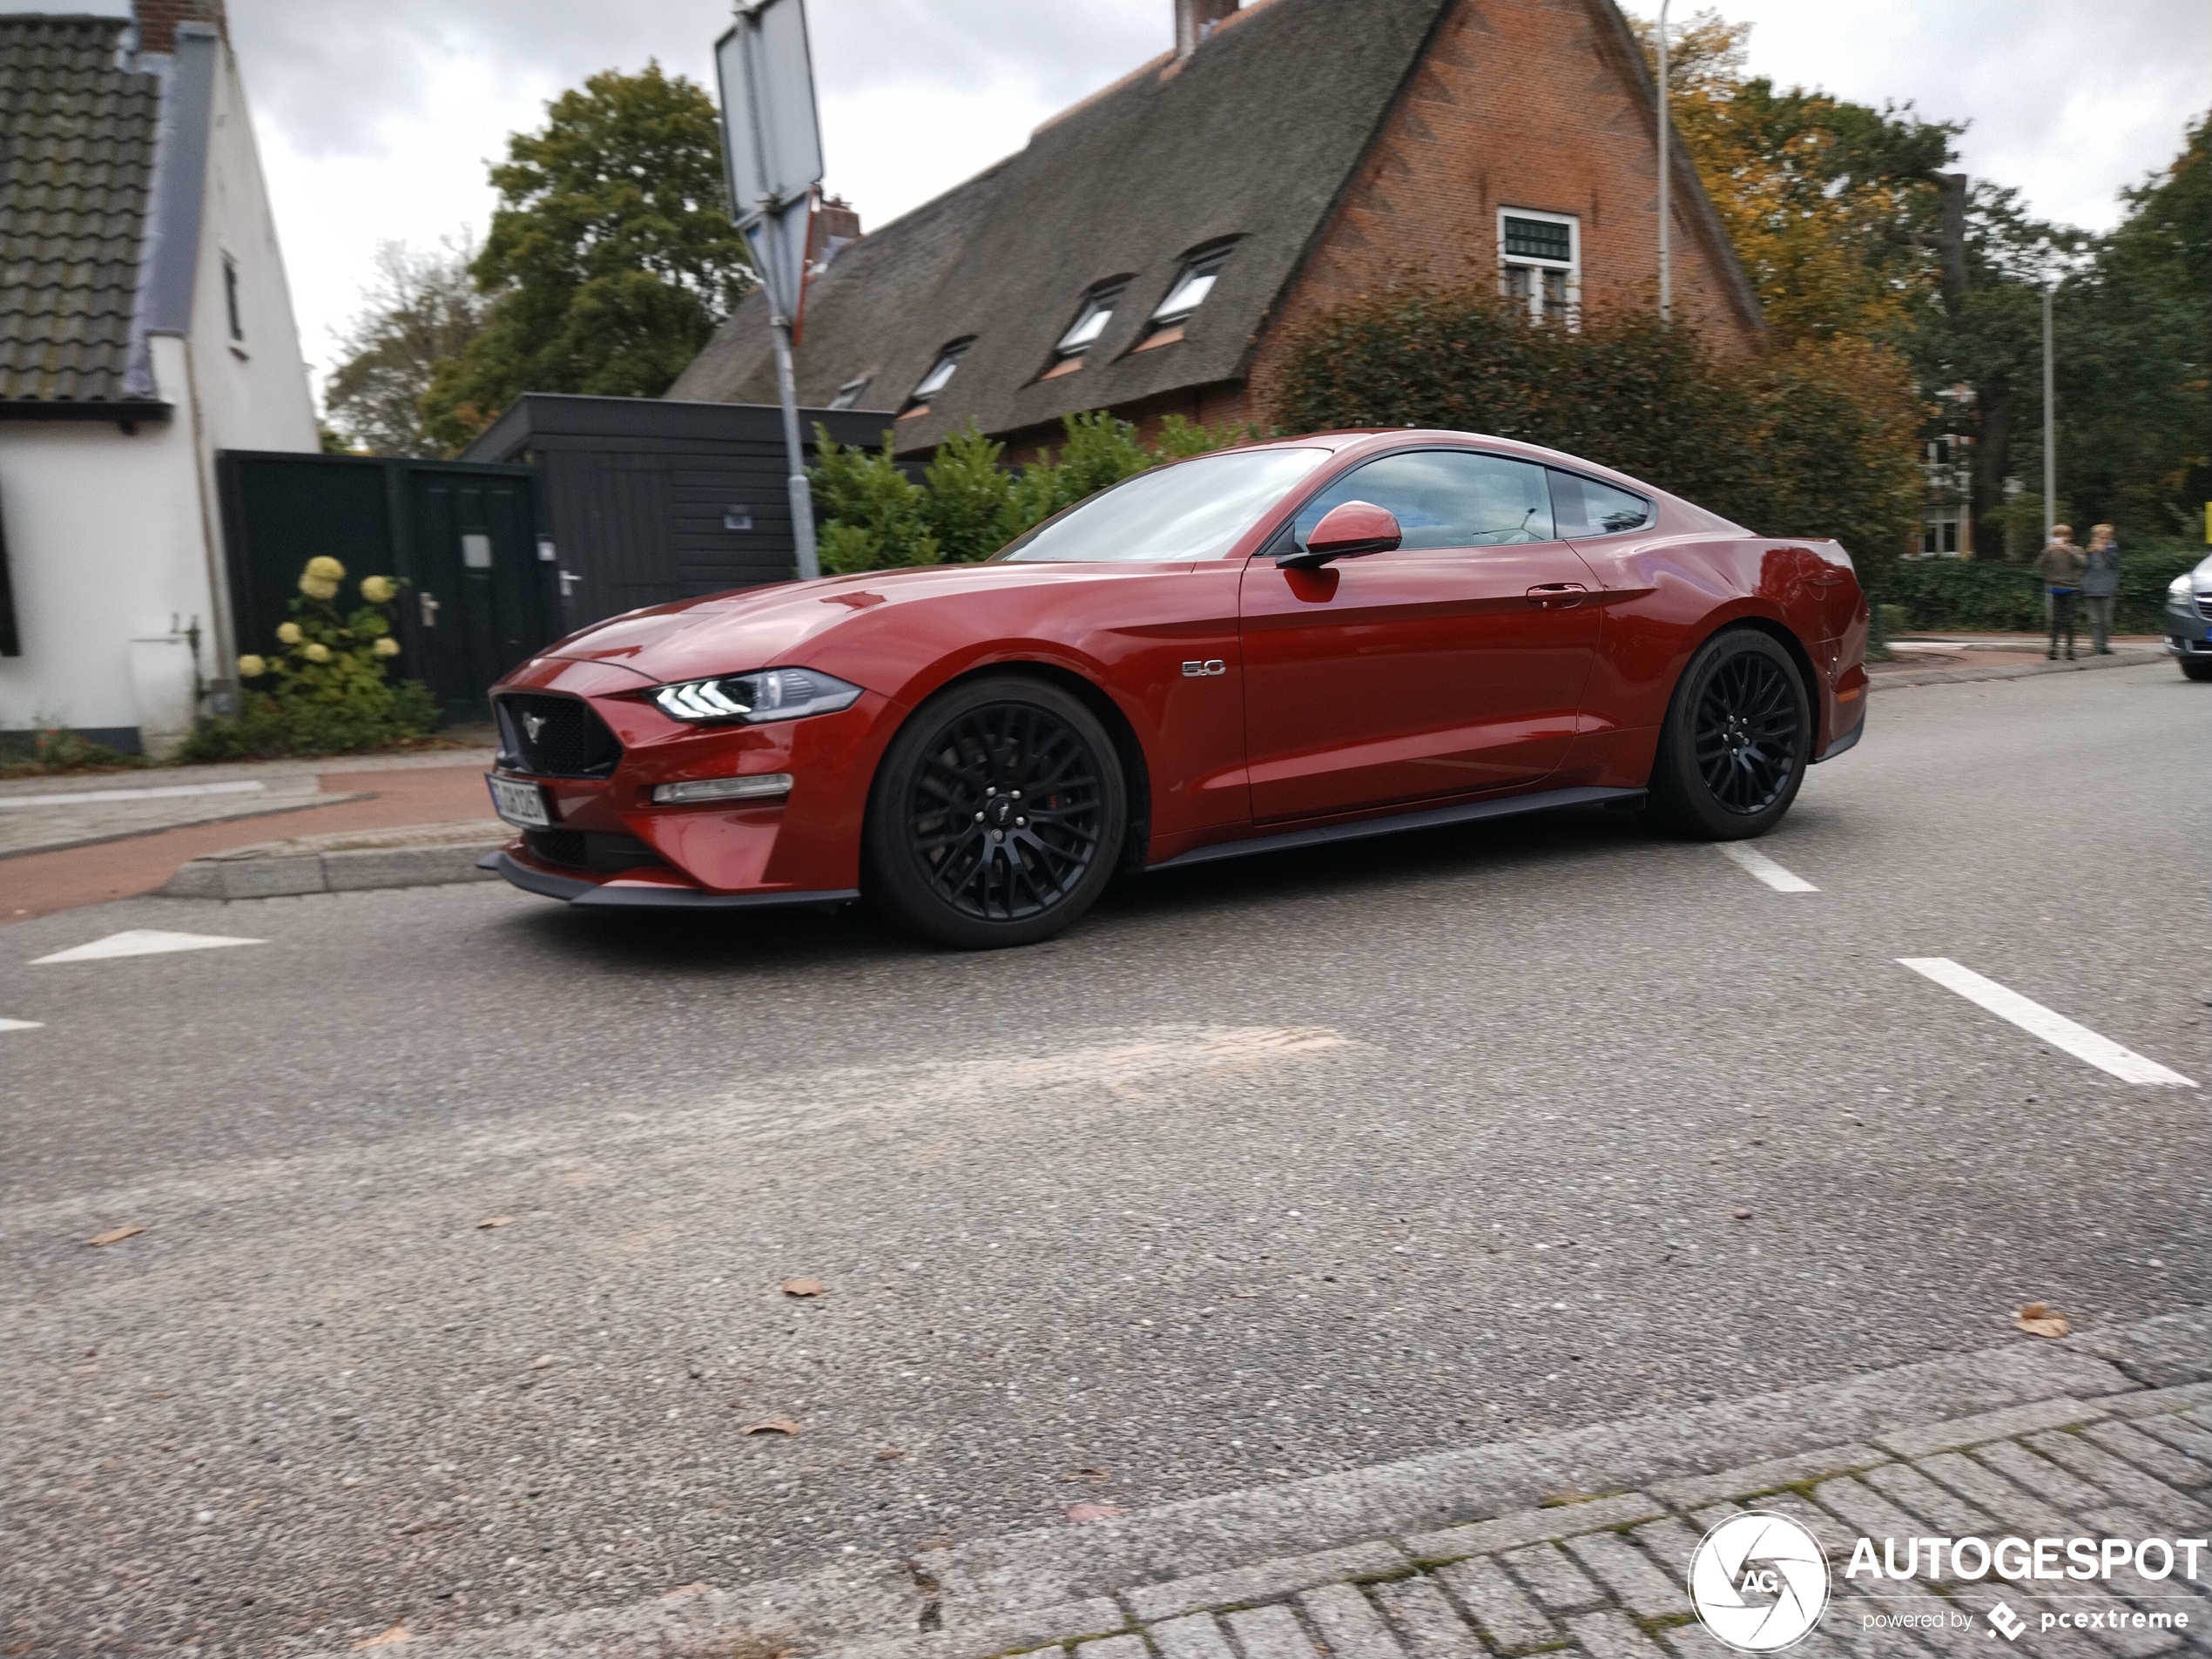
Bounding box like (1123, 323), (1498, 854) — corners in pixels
(810, 409), (1248, 575)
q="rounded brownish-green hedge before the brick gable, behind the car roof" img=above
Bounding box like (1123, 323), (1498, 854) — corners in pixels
(1272, 286), (1925, 583)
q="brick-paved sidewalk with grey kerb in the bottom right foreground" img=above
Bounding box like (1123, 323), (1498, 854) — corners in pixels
(349, 1310), (2212, 1659)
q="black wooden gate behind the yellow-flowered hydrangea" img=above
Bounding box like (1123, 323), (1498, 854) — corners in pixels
(217, 449), (564, 721)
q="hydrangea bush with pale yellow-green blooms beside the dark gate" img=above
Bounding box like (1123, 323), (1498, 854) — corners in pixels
(179, 557), (438, 761)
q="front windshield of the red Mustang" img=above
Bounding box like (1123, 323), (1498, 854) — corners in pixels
(998, 449), (1330, 564)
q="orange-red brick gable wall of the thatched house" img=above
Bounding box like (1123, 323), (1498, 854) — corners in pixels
(1250, 0), (1758, 418)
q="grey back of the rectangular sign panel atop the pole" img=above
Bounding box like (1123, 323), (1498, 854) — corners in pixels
(714, 0), (823, 224)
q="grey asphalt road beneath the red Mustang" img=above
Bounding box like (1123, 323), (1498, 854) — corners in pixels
(0, 666), (2212, 1655)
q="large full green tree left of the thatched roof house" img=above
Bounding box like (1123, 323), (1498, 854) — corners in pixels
(422, 62), (752, 449)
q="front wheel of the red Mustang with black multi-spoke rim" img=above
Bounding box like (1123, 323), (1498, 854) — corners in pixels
(865, 675), (1128, 951)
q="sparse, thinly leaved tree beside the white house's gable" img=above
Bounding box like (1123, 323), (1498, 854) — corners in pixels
(323, 230), (491, 455)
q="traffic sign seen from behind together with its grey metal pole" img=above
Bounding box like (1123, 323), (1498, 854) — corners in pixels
(714, 0), (823, 579)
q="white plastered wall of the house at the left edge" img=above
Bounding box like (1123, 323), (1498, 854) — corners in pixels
(0, 336), (214, 743)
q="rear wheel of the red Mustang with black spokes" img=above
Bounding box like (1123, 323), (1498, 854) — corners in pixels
(1650, 628), (1814, 840)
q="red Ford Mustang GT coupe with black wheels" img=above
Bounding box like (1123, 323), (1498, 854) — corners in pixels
(487, 431), (1867, 947)
